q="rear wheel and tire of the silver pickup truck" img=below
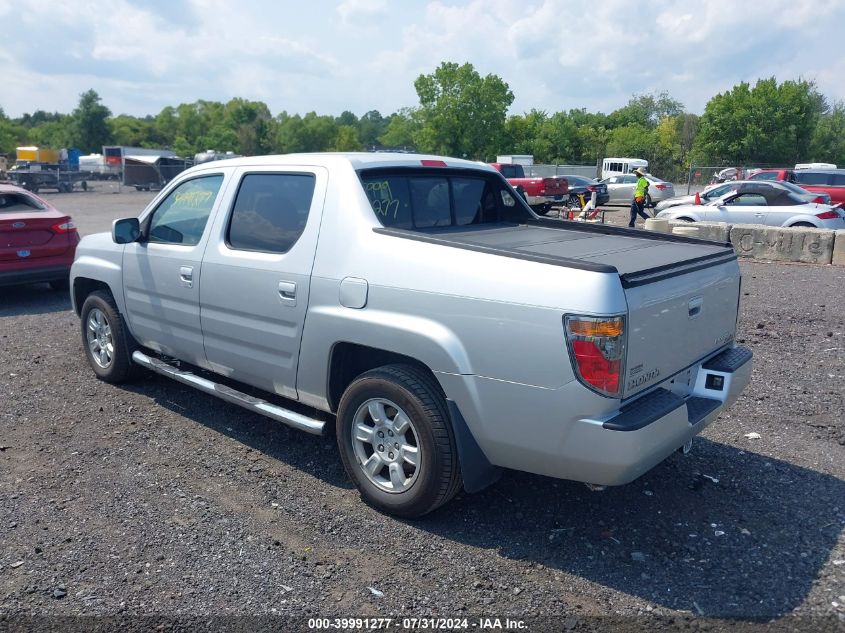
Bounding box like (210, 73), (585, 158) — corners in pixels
(335, 365), (461, 518)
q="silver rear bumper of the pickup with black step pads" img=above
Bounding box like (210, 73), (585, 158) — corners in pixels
(438, 347), (752, 486)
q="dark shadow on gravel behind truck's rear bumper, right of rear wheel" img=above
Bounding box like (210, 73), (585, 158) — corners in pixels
(413, 438), (845, 618)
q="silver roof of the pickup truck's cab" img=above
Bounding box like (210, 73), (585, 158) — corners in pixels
(181, 152), (495, 171)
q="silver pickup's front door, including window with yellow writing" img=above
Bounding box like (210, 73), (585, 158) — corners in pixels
(123, 174), (223, 365)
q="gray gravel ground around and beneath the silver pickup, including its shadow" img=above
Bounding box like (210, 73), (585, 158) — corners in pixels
(0, 193), (845, 631)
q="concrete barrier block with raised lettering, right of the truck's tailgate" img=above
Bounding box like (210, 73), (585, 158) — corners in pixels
(730, 224), (834, 264)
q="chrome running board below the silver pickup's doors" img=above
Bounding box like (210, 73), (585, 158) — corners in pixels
(132, 351), (326, 435)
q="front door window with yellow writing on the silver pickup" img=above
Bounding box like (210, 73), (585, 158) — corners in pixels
(147, 175), (223, 246)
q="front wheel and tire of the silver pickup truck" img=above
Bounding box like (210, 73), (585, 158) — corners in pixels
(80, 290), (139, 383)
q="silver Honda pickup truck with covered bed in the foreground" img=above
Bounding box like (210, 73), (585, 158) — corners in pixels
(71, 153), (751, 516)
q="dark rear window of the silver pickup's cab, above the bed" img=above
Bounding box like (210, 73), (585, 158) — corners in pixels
(361, 171), (530, 229)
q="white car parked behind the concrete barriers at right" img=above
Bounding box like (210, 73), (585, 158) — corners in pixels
(657, 182), (845, 229)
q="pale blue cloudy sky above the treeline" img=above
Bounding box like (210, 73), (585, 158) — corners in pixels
(0, 0), (845, 116)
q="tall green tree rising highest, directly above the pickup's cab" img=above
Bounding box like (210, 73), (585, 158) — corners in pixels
(414, 62), (514, 159)
